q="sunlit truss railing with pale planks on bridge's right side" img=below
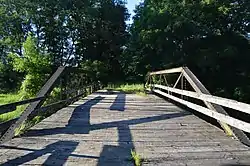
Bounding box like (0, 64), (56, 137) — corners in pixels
(145, 67), (250, 145)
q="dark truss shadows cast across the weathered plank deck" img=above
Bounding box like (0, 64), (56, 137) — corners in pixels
(0, 93), (190, 166)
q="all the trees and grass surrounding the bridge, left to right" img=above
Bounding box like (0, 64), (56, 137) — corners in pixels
(0, 0), (250, 139)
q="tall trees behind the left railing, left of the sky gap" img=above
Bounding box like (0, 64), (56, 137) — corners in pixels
(0, 0), (129, 92)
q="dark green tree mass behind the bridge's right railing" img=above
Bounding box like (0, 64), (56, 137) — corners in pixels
(124, 0), (250, 102)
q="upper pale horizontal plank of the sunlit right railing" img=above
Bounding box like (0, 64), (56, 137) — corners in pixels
(154, 84), (250, 114)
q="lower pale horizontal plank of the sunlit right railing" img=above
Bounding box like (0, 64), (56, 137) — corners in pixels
(153, 90), (250, 133)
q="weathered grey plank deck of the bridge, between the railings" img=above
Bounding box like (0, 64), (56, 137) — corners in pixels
(0, 91), (250, 166)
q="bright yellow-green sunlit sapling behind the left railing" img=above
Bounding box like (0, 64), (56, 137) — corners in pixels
(9, 35), (50, 98)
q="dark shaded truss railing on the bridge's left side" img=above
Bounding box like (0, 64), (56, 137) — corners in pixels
(0, 67), (101, 144)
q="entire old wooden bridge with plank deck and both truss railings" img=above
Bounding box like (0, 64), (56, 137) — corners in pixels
(0, 67), (250, 166)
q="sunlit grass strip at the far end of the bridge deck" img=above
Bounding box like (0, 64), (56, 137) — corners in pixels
(106, 84), (146, 96)
